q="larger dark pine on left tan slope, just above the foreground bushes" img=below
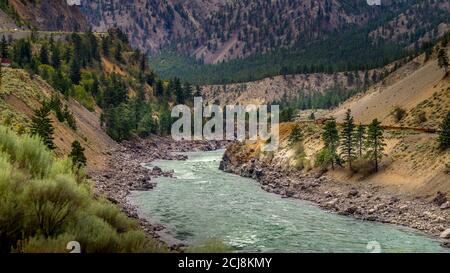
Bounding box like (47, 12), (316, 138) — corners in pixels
(30, 103), (55, 150)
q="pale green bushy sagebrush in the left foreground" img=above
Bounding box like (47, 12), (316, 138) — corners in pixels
(0, 126), (165, 253)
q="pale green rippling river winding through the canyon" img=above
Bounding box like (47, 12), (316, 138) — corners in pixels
(130, 151), (448, 252)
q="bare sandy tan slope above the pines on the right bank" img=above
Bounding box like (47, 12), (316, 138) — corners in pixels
(330, 46), (450, 129)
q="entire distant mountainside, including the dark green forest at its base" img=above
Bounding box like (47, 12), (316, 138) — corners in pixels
(82, 0), (450, 84)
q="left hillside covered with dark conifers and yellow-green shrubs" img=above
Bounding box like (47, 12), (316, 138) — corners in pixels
(1, 29), (197, 141)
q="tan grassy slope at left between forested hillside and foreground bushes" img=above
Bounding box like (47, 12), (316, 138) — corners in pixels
(0, 68), (116, 169)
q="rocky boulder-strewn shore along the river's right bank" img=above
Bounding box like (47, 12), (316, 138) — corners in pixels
(220, 144), (450, 247)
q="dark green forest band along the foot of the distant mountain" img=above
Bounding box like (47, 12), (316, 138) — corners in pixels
(150, 1), (449, 84)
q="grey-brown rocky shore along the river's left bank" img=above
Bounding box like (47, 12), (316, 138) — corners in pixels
(89, 136), (226, 250)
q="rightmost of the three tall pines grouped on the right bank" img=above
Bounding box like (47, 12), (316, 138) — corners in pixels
(366, 119), (386, 172)
